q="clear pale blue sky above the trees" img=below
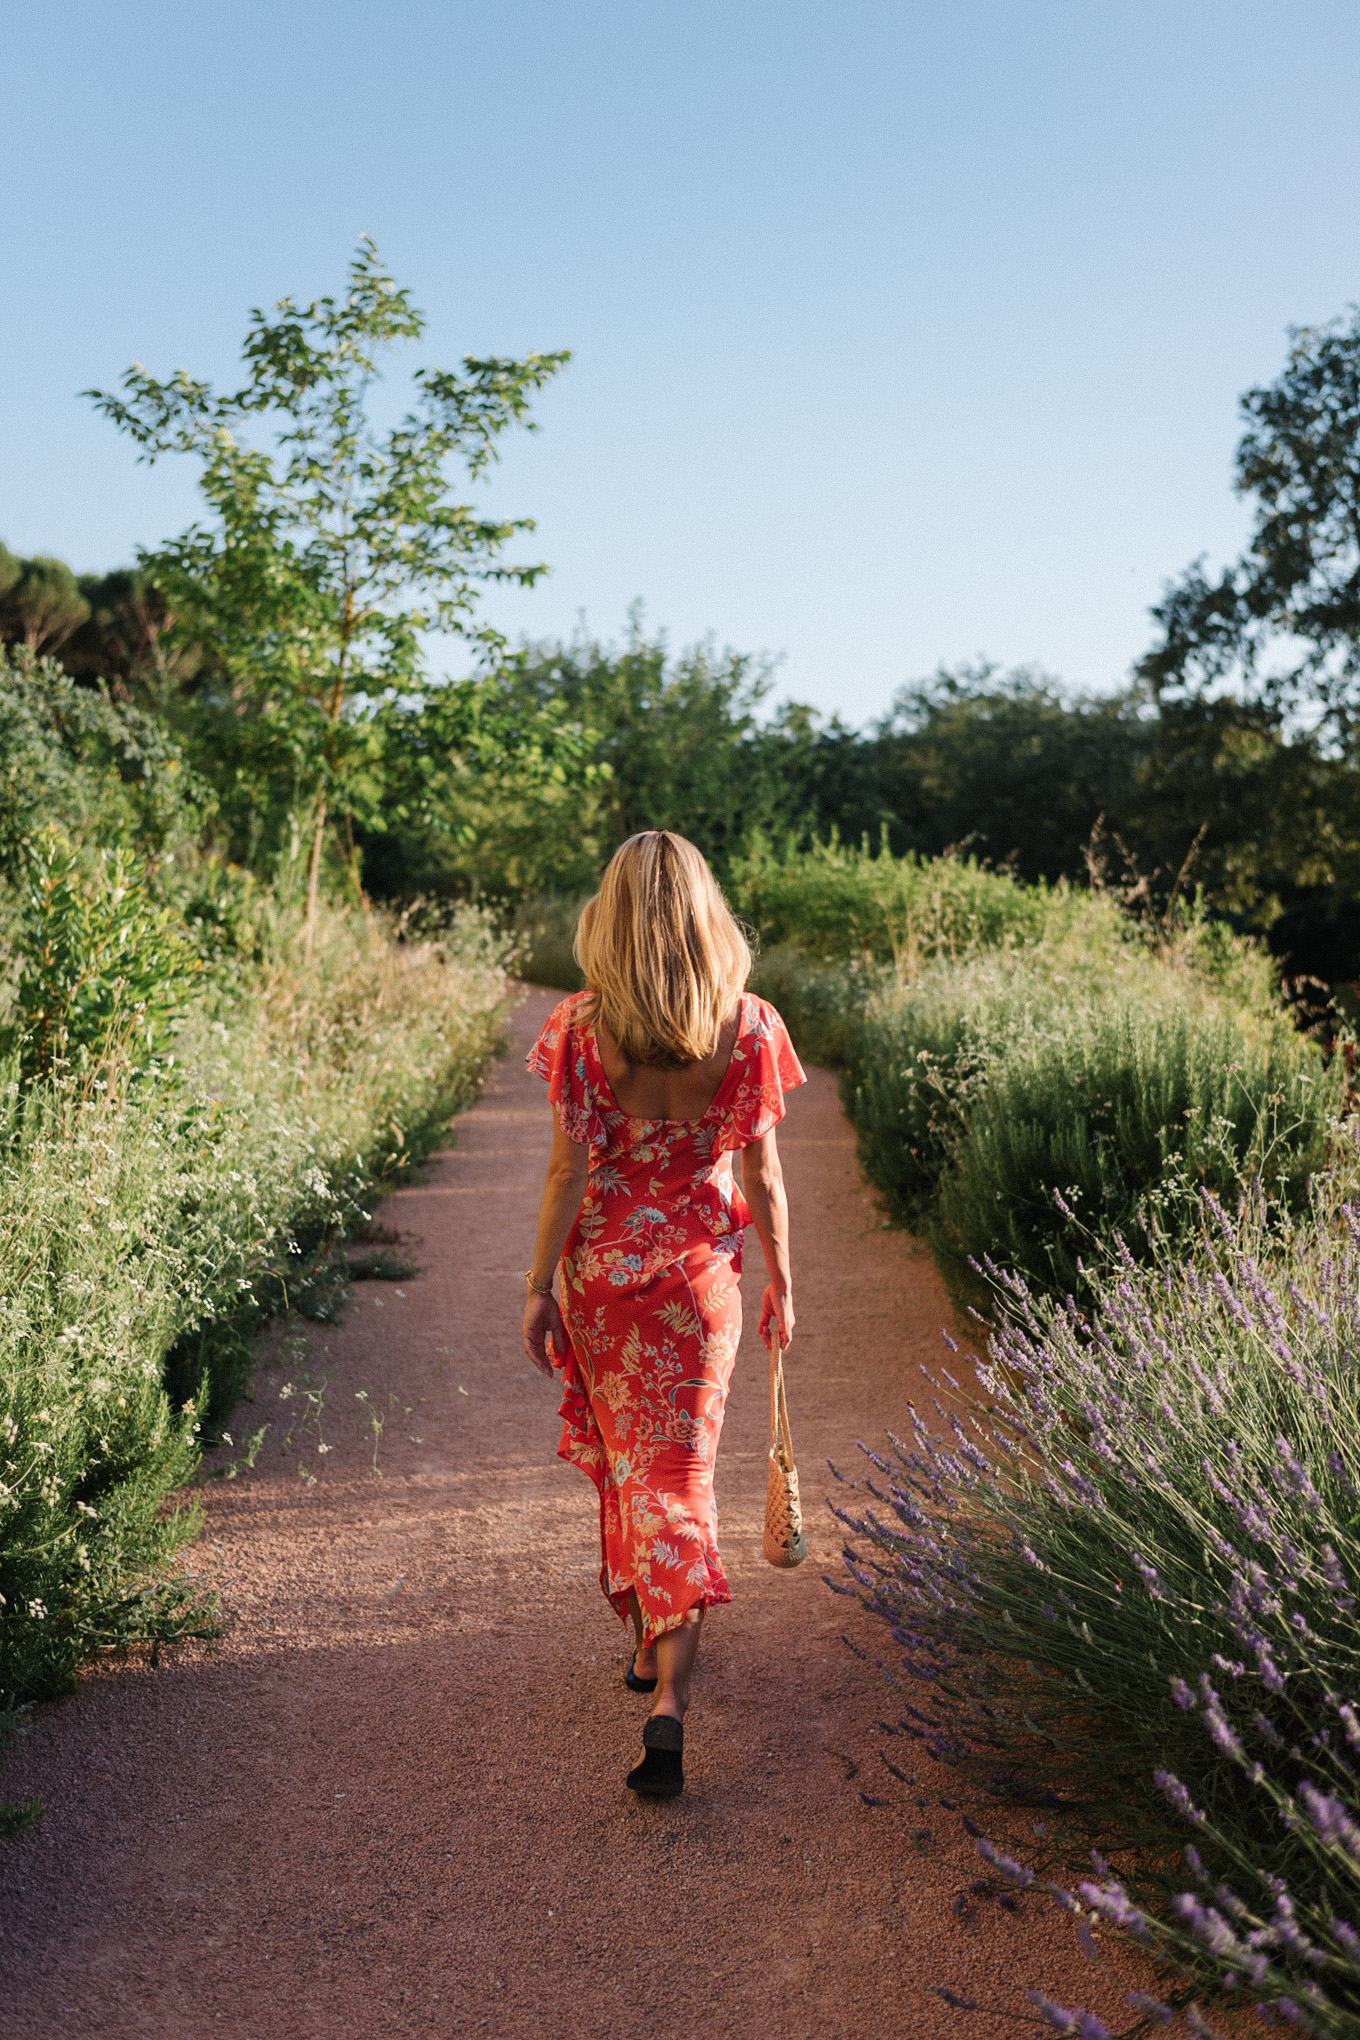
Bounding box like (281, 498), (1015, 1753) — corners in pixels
(0, 0), (1360, 720)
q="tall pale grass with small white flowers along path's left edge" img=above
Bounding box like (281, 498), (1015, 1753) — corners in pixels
(0, 900), (506, 1710)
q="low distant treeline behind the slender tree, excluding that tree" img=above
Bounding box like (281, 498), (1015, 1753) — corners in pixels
(0, 551), (1360, 985)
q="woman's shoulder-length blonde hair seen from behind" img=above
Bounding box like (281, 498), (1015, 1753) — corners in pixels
(573, 828), (750, 1069)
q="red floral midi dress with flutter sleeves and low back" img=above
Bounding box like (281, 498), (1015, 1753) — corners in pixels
(528, 991), (805, 1642)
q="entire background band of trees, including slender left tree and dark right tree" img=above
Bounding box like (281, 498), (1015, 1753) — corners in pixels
(0, 301), (1360, 985)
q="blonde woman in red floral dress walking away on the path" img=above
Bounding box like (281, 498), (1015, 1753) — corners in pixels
(524, 830), (803, 1797)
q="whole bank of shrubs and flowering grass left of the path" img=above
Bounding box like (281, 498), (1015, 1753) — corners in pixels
(0, 659), (506, 1811)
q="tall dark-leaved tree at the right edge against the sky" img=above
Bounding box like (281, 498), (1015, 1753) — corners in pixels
(1138, 306), (1360, 981)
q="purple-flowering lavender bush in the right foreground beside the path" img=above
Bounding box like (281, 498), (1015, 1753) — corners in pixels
(838, 1183), (1360, 2036)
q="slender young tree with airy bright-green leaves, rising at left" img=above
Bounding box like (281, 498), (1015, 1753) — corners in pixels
(90, 241), (567, 942)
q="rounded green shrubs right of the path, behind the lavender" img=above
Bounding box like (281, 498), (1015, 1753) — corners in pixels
(738, 845), (1313, 1297)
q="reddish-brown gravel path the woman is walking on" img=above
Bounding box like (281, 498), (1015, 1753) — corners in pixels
(0, 991), (1128, 2040)
